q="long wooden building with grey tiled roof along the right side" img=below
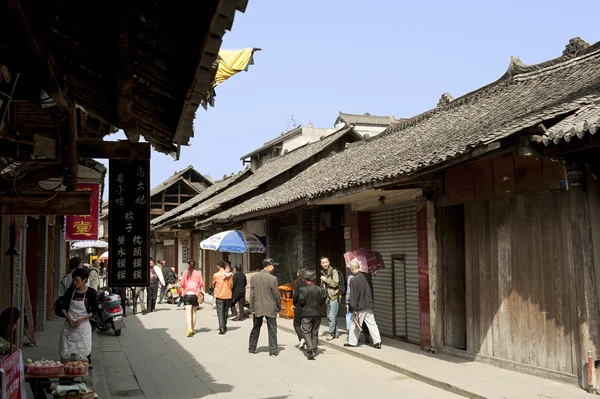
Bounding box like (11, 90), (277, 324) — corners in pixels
(195, 38), (600, 388)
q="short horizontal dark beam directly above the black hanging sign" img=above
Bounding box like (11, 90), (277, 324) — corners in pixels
(77, 141), (151, 160)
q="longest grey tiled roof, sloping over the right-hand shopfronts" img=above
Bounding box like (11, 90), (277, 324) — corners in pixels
(205, 39), (600, 227)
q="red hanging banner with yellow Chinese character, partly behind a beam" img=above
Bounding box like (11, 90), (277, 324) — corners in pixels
(65, 183), (100, 241)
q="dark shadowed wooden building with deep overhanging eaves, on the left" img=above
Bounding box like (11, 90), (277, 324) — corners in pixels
(0, 0), (247, 342)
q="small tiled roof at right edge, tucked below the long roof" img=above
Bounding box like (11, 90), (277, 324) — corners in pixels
(541, 102), (600, 146)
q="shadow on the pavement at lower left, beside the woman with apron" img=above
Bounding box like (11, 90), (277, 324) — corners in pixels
(99, 309), (234, 399)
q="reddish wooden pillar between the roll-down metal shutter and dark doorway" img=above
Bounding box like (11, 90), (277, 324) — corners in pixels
(417, 197), (431, 349)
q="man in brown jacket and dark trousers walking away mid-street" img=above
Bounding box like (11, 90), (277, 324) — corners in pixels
(248, 258), (281, 356)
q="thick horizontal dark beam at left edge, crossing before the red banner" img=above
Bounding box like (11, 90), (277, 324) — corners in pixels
(0, 191), (91, 215)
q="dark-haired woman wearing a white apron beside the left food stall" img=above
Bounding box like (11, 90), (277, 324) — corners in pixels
(58, 269), (98, 363)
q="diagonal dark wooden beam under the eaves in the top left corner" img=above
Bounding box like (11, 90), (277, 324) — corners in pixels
(8, 0), (73, 112)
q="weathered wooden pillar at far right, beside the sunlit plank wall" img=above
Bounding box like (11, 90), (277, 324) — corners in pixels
(566, 162), (600, 389)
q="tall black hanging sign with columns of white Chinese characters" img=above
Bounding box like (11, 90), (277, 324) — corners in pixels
(108, 159), (150, 287)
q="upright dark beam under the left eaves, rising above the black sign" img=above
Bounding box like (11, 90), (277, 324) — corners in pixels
(116, 10), (140, 143)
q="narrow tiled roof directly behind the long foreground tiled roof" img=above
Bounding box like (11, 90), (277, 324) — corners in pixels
(173, 127), (356, 222)
